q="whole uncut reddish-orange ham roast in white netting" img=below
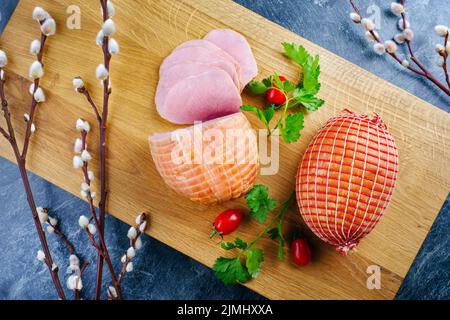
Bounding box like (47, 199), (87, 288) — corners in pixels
(296, 110), (398, 255)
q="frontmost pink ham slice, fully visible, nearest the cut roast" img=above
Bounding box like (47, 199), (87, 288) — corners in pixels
(156, 69), (242, 124)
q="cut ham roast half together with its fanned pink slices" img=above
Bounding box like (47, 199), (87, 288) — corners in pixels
(149, 29), (259, 204)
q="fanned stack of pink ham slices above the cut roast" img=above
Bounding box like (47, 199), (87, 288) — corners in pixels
(155, 29), (258, 124)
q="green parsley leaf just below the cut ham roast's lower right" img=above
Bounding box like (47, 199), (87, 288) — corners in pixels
(244, 185), (277, 223)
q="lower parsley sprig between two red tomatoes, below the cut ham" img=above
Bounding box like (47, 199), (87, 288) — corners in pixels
(213, 185), (295, 285)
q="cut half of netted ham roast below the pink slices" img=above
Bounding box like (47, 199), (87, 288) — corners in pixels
(149, 112), (259, 204)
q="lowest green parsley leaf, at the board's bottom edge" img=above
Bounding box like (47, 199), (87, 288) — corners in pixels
(213, 257), (251, 285)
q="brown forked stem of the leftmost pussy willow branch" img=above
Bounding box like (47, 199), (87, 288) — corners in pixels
(0, 62), (66, 299)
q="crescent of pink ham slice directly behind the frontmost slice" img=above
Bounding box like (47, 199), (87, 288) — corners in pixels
(159, 46), (243, 91)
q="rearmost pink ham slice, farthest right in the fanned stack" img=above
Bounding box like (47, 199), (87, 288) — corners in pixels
(204, 29), (258, 86)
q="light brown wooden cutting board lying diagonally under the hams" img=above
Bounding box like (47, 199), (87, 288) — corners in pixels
(0, 0), (450, 299)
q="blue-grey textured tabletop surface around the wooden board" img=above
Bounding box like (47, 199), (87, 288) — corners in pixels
(0, 0), (450, 299)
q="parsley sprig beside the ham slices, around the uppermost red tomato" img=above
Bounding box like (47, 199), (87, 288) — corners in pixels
(241, 43), (325, 143)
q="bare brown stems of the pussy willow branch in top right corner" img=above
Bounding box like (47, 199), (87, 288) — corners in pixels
(349, 0), (450, 96)
